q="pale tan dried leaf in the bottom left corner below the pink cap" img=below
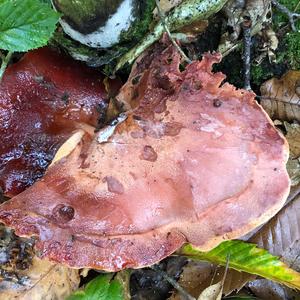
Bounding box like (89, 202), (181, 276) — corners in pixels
(0, 257), (79, 300)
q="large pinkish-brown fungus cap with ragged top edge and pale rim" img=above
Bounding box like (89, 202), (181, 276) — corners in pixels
(0, 46), (289, 271)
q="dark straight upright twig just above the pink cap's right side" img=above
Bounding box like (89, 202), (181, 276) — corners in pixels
(242, 18), (252, 91)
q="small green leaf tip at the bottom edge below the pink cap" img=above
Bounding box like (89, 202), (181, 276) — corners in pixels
(67, 274), (124, 300)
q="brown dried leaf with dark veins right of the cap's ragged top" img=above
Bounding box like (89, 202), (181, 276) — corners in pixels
(260, 70), (300, 121)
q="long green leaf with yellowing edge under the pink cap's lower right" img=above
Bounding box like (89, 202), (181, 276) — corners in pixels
(180, 241), (300, 289)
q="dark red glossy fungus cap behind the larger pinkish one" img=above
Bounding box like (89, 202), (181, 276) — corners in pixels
(0, 48), (119, 196)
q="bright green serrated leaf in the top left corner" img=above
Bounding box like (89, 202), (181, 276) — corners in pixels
(0, 0), (60, 52)
